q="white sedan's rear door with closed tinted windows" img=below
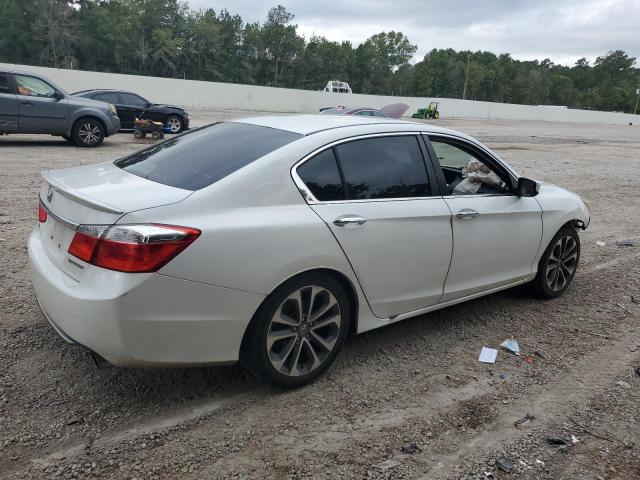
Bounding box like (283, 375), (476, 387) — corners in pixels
(294, 134), (452, 318)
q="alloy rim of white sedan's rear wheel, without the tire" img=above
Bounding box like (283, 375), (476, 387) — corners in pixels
(266, 285), (342, 376)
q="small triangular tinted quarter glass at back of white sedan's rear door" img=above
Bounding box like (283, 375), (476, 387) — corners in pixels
(297, 148), (345, 202)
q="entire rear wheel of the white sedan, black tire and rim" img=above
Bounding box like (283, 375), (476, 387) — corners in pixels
(241, 273), (350, 388)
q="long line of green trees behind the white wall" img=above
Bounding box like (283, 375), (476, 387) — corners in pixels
(0, 0), (640, 112)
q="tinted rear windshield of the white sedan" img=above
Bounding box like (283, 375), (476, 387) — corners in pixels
(114, 123), (302, 190)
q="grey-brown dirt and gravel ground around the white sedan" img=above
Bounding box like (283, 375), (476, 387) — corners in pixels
(0, 112), (640, 480)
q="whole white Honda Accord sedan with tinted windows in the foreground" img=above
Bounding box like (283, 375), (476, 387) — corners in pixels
(29, 115), (590, 386)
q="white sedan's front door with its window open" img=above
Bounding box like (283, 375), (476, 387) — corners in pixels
(422, 135), (542, 302)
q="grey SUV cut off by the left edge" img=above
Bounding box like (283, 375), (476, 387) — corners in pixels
(0, 71), (120, 147)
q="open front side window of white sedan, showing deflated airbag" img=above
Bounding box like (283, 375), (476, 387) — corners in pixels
(430, 138), (509, 195)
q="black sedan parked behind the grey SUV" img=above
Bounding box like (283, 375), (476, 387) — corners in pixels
(73, 89), (189, 133)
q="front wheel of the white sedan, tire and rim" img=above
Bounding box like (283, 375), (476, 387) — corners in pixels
(531, 226), (580, 299)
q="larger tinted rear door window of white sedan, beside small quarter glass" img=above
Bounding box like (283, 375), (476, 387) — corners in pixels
(336, 135), (431, 200)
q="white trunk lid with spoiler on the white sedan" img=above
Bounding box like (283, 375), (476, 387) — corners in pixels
(39, 162), (192, 280)
